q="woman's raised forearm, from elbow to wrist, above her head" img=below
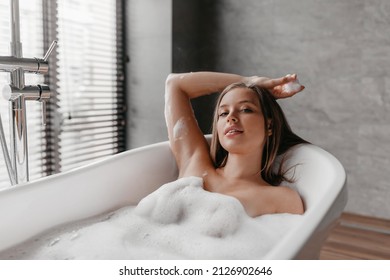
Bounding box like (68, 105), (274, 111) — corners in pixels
(166, 72), (247, 98)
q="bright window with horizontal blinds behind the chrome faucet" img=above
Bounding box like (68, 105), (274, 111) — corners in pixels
(0, 0), (126, 188)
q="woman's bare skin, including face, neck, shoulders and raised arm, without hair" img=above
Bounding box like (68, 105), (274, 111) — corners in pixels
(165, 72), (304, 217)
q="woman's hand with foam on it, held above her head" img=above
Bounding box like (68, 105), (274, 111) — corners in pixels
(248, 74), (305, 99)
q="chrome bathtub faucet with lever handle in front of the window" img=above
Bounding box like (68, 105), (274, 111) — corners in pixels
(0, 0), (57, 185)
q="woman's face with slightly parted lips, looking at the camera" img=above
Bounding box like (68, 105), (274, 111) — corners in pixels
(217, 88), (265, 153)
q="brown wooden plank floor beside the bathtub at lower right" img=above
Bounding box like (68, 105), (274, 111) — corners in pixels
(320, 213), (390, 260)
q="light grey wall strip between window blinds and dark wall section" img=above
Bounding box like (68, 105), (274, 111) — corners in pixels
(127, 0), (172, 148)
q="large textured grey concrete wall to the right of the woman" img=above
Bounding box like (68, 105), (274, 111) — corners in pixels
(214, 0), (390, 219)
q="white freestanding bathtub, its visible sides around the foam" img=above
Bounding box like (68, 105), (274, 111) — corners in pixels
(0, 137), (347, 259)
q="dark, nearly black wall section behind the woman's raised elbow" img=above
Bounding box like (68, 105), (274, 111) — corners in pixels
(172, 0), (219, 134)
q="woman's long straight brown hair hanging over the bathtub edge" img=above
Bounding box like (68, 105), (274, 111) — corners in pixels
(210, 83), (308, 186)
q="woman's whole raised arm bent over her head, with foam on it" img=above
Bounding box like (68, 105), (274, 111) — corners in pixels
(165, 72), (302, 177)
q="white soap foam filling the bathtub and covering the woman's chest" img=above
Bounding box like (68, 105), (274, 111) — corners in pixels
(0, 177), (301, 259)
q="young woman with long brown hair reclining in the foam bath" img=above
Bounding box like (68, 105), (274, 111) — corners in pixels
(165, 72), (306, 217)
